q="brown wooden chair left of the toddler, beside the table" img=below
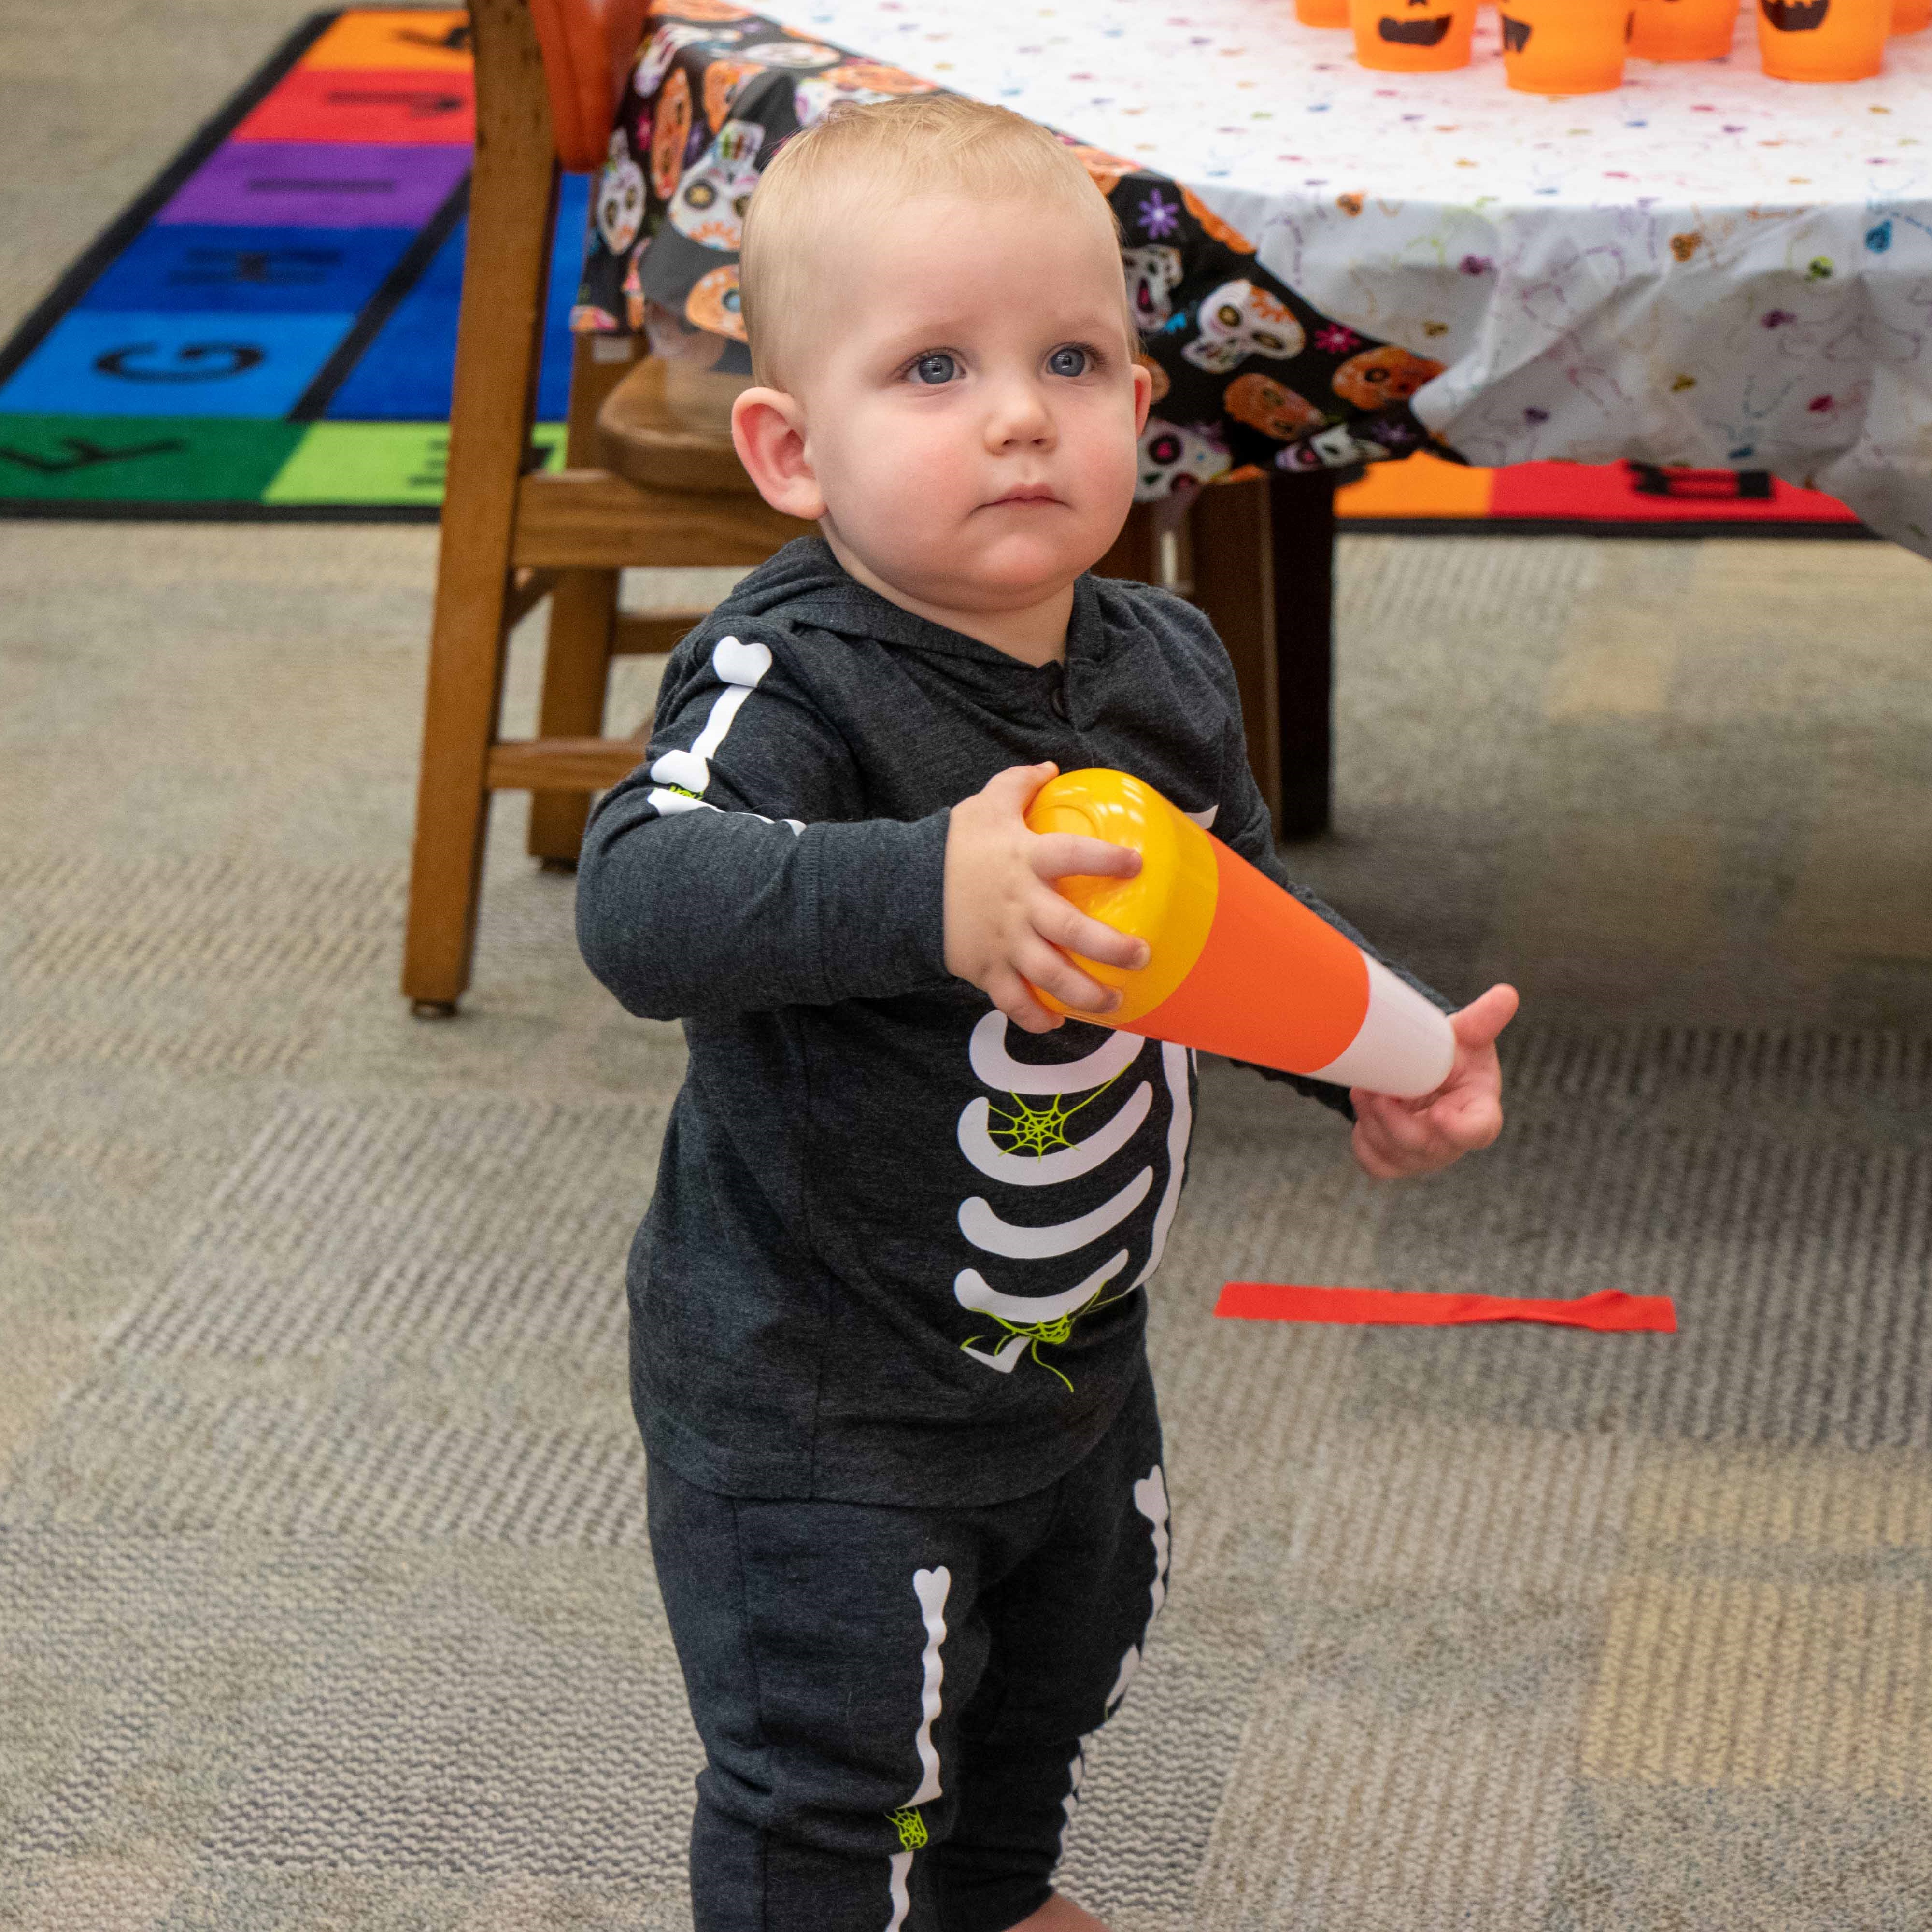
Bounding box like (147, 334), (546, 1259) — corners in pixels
(402, 0), (808, 1016)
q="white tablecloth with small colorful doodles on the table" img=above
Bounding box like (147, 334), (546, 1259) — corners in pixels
(767, 0), (1932, 556)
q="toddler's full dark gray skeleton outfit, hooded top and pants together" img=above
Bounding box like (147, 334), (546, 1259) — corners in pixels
(578, 537), (1435, 1932)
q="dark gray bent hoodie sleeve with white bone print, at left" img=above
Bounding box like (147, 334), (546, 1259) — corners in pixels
(578, 634), (949, 1020)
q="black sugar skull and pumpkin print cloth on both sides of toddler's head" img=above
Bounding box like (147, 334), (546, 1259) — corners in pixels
(572, 0), (1453, 483)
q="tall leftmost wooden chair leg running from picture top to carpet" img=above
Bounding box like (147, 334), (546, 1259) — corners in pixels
(402, 0), (556, 1014)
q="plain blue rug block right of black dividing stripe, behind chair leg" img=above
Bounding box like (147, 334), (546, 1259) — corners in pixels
(323, 174), (591, 423)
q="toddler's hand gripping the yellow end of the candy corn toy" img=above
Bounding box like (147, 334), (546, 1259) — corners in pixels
(945, 765), (1151, 1036)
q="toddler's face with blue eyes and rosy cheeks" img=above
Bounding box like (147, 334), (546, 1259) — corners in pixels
(790, 193), (1148, 612)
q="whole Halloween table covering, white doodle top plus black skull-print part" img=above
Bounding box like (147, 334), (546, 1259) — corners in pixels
(576, 0), (1932, 554)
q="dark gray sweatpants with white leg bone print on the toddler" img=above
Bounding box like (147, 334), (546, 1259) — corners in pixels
(649, 1378), (1167, 1932)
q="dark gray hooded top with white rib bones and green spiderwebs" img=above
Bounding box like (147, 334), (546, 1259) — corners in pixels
(578, 537), (1435, 1507)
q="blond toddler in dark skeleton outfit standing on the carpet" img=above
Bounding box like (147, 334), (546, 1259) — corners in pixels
(578, 97), (1515, 1932)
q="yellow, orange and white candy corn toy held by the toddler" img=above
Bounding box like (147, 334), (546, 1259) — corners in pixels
(1026, 771), (1455, 1099)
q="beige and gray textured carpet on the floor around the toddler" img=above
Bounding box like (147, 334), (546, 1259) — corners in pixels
(11, 0), (1932, 1932)
